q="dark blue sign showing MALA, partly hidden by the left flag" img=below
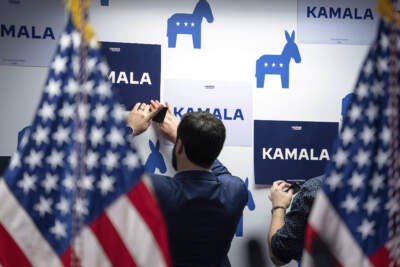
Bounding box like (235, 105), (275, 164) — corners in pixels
(101, 42), (161, 109)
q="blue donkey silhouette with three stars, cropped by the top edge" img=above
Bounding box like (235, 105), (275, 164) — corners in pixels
(167, 0), (214, 48)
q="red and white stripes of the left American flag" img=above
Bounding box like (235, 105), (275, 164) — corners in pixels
(0, 176), (171, 267)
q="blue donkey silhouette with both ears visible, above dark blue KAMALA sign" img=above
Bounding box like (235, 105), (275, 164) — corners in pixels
(256, 31), (301, 88)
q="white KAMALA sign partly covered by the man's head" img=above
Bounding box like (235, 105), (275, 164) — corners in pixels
(164, 80), (253, 146)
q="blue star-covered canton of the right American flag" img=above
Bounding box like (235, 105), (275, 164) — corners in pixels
(323, 22), (390, 256)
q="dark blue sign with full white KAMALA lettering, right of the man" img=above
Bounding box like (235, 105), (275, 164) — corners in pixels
(254, 120), (338, 185)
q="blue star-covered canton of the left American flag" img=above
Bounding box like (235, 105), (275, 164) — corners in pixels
(4, 17), (143, 255)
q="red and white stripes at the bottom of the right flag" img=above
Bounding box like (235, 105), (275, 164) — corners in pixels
(302, 191), (388, 267)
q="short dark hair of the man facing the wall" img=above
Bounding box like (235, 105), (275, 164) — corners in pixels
(177, 111), (225, 168)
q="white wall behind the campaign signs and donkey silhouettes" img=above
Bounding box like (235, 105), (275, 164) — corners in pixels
(0, 0), (372, 267)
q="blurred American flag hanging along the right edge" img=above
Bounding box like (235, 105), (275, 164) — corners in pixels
(302, 21), (400, 267)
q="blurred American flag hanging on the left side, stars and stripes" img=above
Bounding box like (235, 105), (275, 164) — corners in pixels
(0, 13), (170, 267)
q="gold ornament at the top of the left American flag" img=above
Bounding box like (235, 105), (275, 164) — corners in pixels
(67, 0), (94, 44)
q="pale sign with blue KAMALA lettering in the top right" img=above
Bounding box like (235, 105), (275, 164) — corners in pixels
(297, 0), (379, 45)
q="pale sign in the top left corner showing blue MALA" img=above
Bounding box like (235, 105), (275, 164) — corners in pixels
(0, 0), (65, 67)
